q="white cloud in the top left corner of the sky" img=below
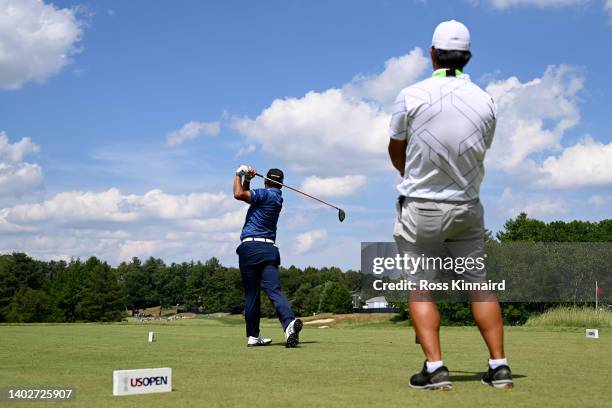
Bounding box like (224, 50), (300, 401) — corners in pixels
(0, 0), (83, 89)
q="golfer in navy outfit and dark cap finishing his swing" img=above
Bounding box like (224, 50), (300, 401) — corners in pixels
(234, 165), (302, 347)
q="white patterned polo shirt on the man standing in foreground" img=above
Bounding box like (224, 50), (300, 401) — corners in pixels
(389, 69), (496, 201)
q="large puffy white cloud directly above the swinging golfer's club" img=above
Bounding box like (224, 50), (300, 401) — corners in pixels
(234, 89), (389, 173)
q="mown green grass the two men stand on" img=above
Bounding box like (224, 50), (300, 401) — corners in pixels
(0, 317), (612, 407)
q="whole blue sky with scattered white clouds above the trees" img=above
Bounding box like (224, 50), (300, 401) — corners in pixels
(0, 0), (612, 268)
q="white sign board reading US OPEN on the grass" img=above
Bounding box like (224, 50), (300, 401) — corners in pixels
(113, 368), (172, 395)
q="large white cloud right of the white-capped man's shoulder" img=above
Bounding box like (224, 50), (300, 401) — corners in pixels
(486, 65), (612, 189)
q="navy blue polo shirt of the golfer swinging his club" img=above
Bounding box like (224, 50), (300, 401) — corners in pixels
(240, 187), (283, 240)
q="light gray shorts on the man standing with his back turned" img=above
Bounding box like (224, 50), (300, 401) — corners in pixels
(393, 197), (487, 282)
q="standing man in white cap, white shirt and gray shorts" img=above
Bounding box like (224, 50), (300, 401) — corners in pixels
(389, 20), (513, 389)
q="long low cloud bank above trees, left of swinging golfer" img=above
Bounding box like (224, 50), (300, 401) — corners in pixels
(0, 188), (247, 263)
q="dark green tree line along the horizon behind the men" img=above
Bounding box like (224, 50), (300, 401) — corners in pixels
(0, 214), (612, 324)
